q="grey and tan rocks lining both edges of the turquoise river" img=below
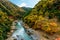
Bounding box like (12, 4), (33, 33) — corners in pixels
(6, 20), (40, 40)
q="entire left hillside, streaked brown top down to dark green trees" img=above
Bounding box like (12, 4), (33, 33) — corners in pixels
(0, 0), (25, 40)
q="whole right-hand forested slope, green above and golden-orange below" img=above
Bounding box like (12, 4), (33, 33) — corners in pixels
(24, 0), (60, 34)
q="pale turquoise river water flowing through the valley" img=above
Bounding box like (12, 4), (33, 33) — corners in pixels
(12, 21), (32, 40)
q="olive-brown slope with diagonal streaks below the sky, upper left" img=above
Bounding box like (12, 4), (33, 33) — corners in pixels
(0, 0), (24, 17)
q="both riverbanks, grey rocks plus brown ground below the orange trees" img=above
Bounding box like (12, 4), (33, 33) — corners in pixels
(7, 20), (60, 40)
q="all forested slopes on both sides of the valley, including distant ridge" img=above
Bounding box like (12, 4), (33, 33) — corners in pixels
(0, 0), (60, 40)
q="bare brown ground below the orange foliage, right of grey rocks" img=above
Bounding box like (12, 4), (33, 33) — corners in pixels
(24, 24), (60, 40)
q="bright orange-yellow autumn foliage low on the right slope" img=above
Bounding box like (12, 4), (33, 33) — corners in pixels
(32, 17), (59, 33)
